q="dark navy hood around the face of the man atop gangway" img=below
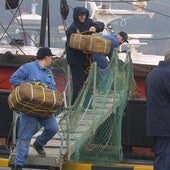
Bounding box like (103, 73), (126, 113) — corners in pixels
(73, 7), (89, 23)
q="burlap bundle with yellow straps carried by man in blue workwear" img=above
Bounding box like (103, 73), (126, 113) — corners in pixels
(8, 83), (62, 118)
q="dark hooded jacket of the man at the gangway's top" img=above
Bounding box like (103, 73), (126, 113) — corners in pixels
(66, 7), (104, 65)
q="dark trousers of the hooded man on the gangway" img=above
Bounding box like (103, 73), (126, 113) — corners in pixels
(70, 65), (89, 104)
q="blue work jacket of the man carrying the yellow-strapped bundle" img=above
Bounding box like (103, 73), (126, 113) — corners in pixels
(9, 60), (57, 90)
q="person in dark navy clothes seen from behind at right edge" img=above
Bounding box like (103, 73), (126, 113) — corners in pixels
(146, 50), (170, 170)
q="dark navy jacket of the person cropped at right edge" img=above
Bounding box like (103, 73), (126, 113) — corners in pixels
(146, 61), (170, 137)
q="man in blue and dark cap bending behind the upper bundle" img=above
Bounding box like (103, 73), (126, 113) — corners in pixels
(93, 31), (128, 70)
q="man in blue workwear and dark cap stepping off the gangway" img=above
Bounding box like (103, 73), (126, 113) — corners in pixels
(10, 47), (58, 170)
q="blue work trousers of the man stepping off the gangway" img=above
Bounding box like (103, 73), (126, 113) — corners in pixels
(15, 113), (59, 166)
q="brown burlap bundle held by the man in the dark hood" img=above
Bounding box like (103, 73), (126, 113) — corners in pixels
(70, 33), (111, 54)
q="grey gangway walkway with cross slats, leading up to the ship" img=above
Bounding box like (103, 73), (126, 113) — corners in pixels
(10, 89), (123, 168)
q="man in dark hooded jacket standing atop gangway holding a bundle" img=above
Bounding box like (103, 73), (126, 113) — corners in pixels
(66, 7), (104, 104)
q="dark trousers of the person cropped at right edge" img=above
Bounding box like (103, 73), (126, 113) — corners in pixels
(153, 137), (170, 170)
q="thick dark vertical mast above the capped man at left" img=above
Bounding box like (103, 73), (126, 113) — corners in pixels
(40, 0), (49, 47)
